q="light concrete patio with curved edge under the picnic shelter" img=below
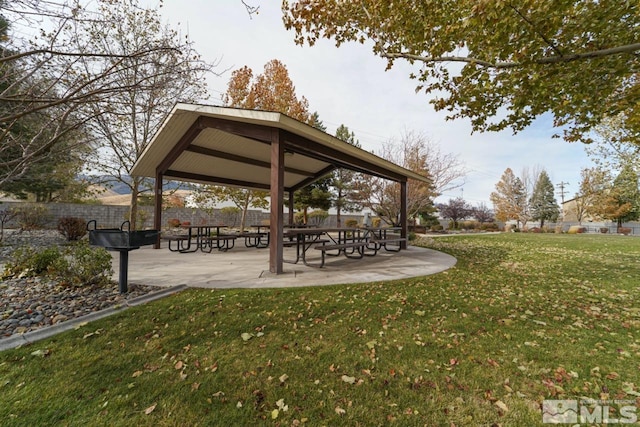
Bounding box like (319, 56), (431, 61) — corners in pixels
(112, 244), (456, 289)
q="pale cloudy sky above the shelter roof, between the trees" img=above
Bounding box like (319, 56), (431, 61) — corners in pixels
(141, 0), (592, 207)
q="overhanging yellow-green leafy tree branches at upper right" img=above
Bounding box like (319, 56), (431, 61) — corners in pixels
(282, 0), (640, 141)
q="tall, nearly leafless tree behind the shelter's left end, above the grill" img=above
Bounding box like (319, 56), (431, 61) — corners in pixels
(80, 0), (213, 228)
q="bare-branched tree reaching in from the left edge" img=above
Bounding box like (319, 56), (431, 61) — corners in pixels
(0, 0), (202, 184)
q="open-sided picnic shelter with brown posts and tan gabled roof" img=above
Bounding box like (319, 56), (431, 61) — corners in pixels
(131, 103), (429, 274)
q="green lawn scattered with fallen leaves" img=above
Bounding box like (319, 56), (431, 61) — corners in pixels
(0, 233), (640, 426)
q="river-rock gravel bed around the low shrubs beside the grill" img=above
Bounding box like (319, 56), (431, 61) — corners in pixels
(0, 230), (160, 340)
